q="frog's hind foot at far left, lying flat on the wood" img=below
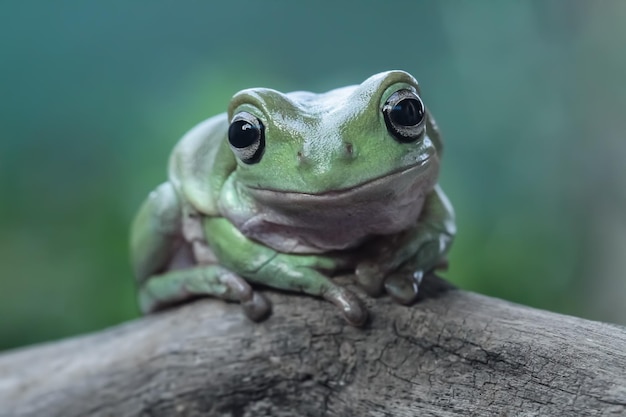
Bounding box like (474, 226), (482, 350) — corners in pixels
(139, 265), (271, 321)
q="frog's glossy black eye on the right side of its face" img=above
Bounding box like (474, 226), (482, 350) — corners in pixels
(382, 90), (426, 143)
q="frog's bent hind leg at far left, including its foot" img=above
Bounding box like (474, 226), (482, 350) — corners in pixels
(131, 183), (269, 320)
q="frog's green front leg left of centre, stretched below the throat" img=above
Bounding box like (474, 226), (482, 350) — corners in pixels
(204, 218), (367, 326)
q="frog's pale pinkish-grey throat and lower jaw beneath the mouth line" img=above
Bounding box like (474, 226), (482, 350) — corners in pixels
(222, 156), (439, 253)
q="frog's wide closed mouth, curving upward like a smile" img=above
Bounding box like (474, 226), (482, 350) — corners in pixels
(246, 157), (437, 204)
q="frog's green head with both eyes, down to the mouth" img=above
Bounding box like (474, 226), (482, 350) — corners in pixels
(228, 71), (440, 206)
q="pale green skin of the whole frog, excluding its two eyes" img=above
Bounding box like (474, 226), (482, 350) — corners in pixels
(131, 71), (455, 325)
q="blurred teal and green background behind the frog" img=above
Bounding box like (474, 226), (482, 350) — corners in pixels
(0, 0), (626, 349)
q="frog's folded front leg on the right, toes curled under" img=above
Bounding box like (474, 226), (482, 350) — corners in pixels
(356, 186), (456, 304)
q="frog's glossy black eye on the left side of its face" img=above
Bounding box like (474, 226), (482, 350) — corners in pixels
(228, 112), (265, 164)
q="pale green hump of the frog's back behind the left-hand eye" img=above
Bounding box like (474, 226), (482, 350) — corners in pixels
(168, 113), (237, 216)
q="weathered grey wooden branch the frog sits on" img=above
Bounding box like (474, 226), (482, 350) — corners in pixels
(0, 272), (626, 417)
